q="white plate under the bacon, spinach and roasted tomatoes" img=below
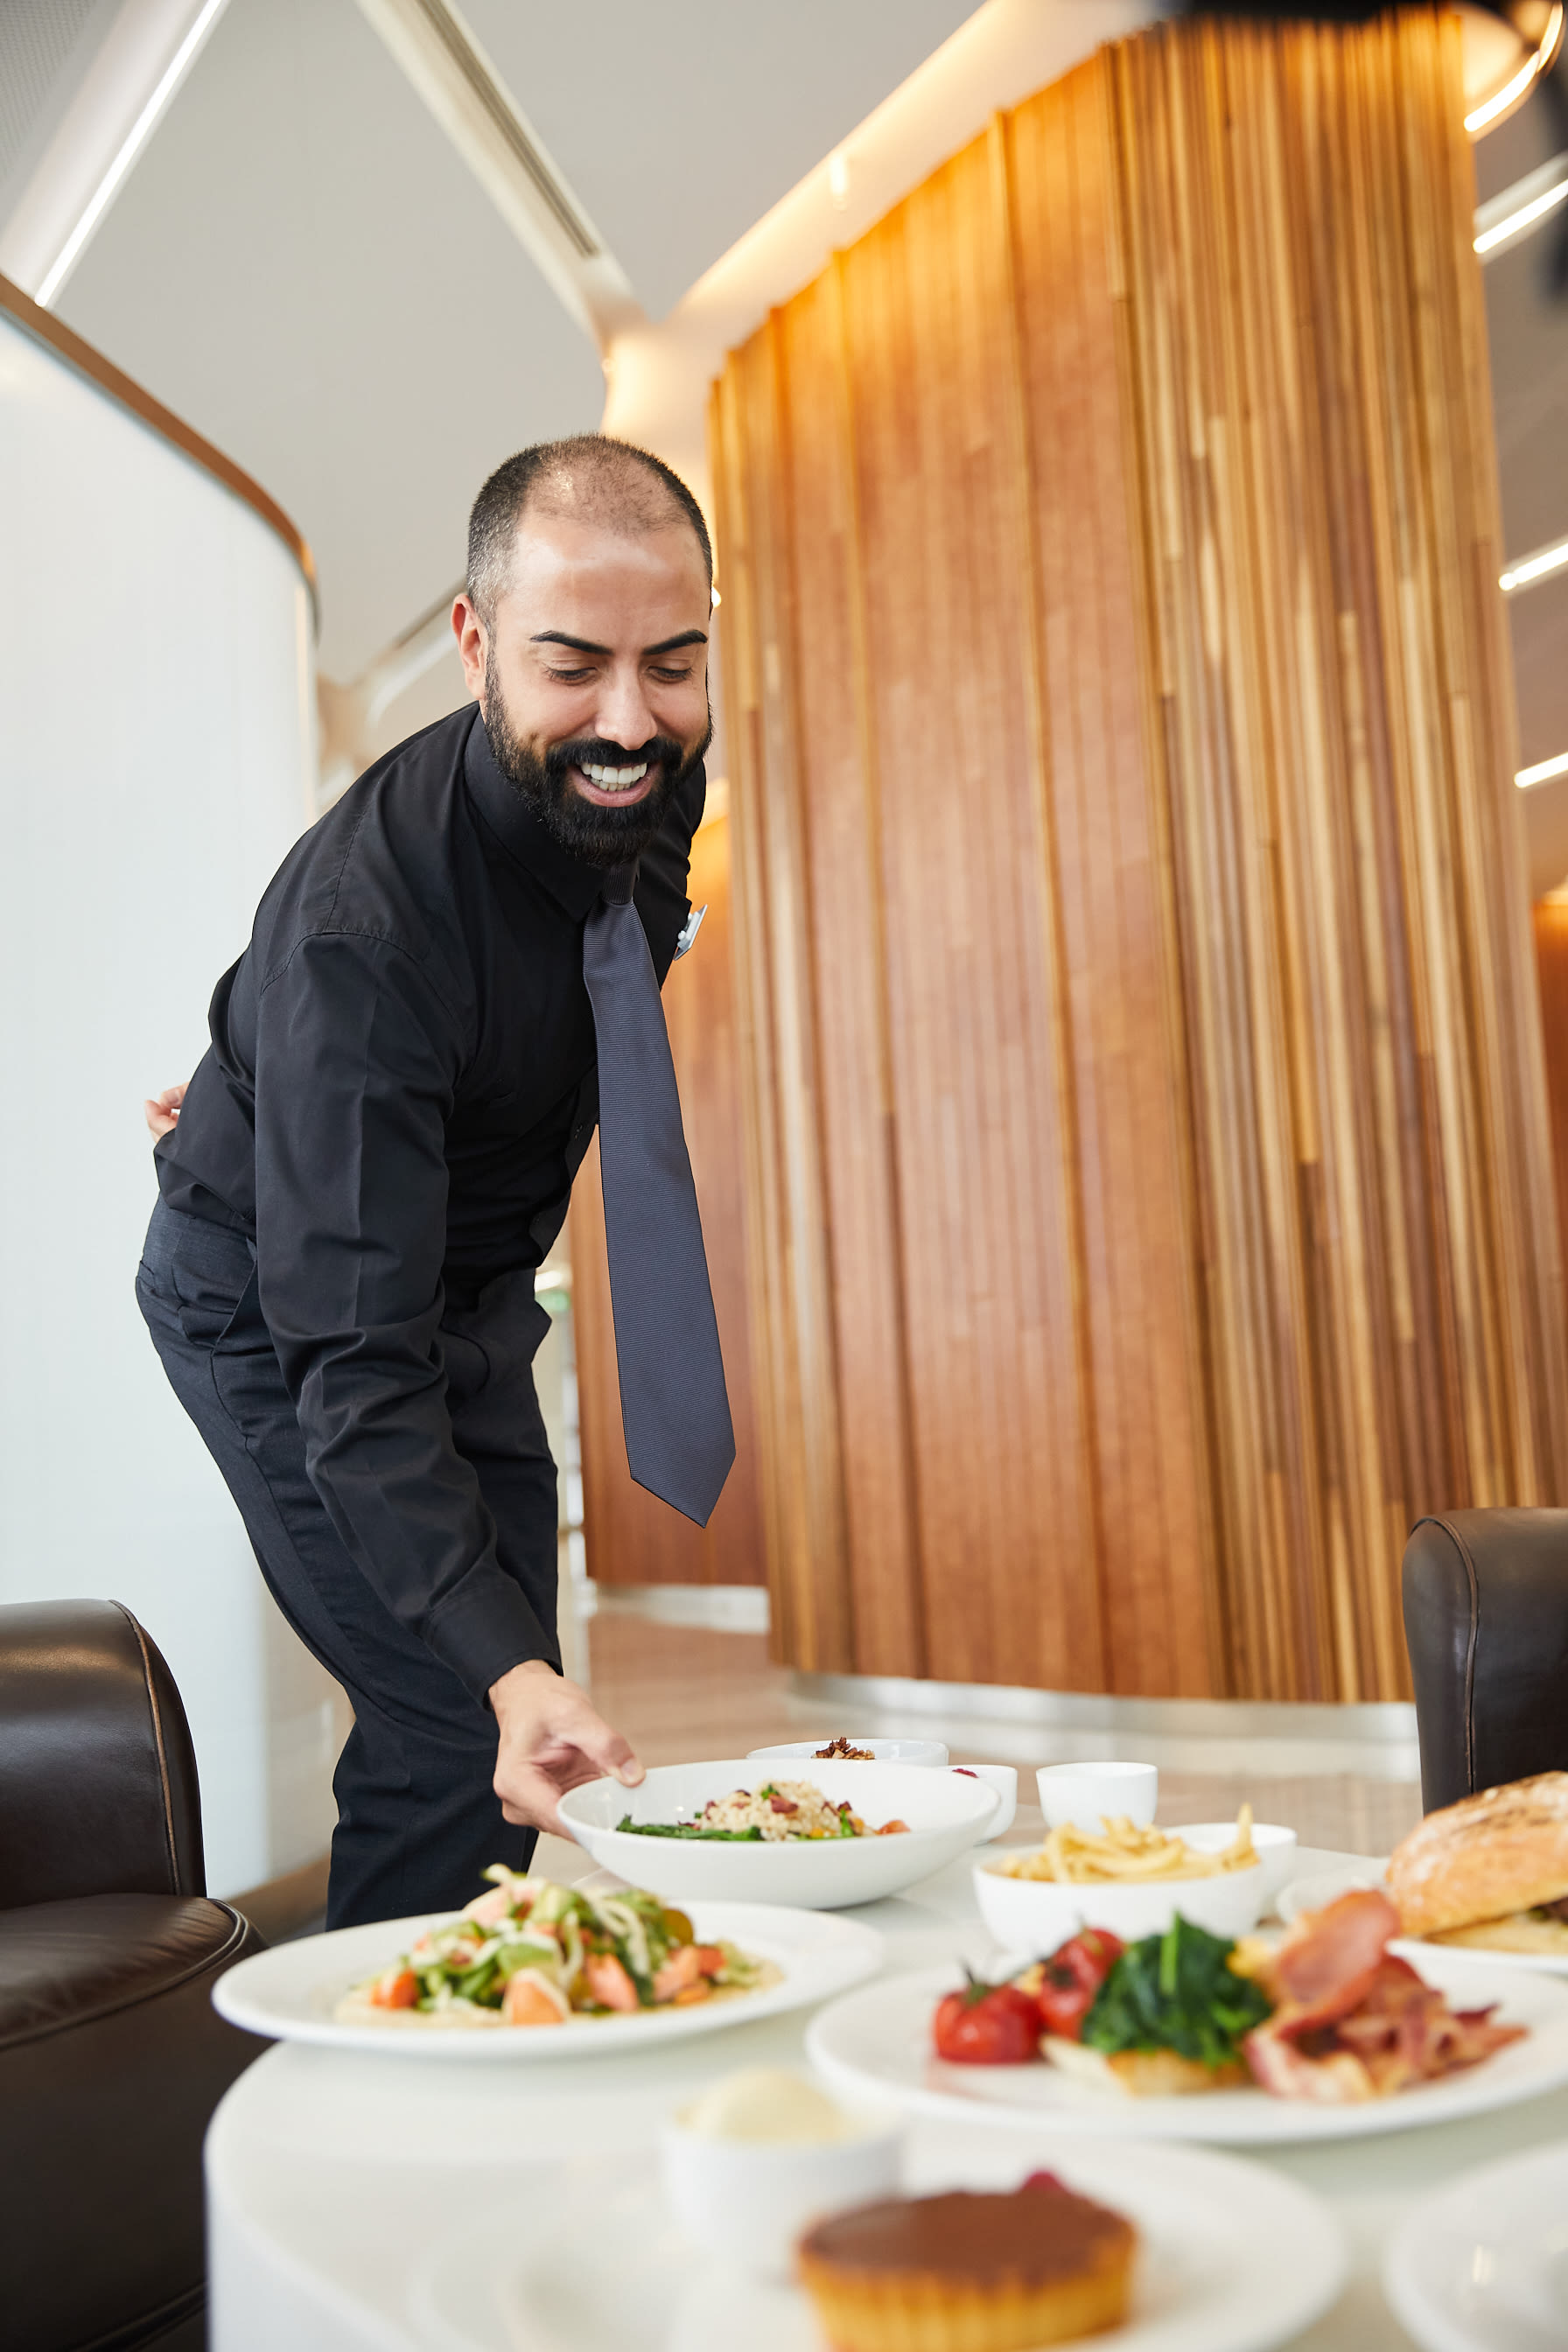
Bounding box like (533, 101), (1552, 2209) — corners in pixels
(807, 1952), (1568, 2145)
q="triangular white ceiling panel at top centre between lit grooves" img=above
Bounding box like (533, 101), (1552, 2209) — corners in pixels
(461, 0), (976, 318)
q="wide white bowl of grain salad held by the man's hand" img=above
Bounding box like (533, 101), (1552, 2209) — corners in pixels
(562, 1757), (999, 1910)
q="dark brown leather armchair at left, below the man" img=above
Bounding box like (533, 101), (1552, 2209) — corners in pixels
(0, 1602), (266, 2352)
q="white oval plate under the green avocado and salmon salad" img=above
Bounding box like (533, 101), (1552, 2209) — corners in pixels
(212, 1903), (881, 2065)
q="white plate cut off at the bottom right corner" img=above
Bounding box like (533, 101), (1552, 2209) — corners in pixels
(1382, 2140), (1568, 2352)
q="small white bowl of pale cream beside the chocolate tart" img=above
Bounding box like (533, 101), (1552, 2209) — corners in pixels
(658, 2117), (903, 2279)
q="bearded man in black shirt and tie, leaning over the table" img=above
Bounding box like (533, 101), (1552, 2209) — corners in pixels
(136, 435), (733, 1926)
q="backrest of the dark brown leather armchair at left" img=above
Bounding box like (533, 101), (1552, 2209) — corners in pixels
(0, 1602), (206, 1910)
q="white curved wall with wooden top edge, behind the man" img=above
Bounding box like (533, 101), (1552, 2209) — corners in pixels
(0, 318), (336, 1894)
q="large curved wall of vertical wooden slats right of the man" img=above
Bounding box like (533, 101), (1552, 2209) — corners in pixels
(712, 10), (1568, 1698)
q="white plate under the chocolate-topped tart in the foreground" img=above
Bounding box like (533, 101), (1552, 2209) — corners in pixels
(411, 2126), (1345, 2352)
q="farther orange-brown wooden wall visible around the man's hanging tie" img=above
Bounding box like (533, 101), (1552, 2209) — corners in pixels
(569, 816), (766, 1586)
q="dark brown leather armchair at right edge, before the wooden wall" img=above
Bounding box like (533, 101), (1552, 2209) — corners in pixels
(1404, 1510), (1568, 1813)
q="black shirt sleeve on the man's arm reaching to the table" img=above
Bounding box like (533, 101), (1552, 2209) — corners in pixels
(256, 934), (552, 1700)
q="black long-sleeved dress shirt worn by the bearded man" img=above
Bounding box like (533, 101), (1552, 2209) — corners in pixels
(158, 705), (703, 1696)
